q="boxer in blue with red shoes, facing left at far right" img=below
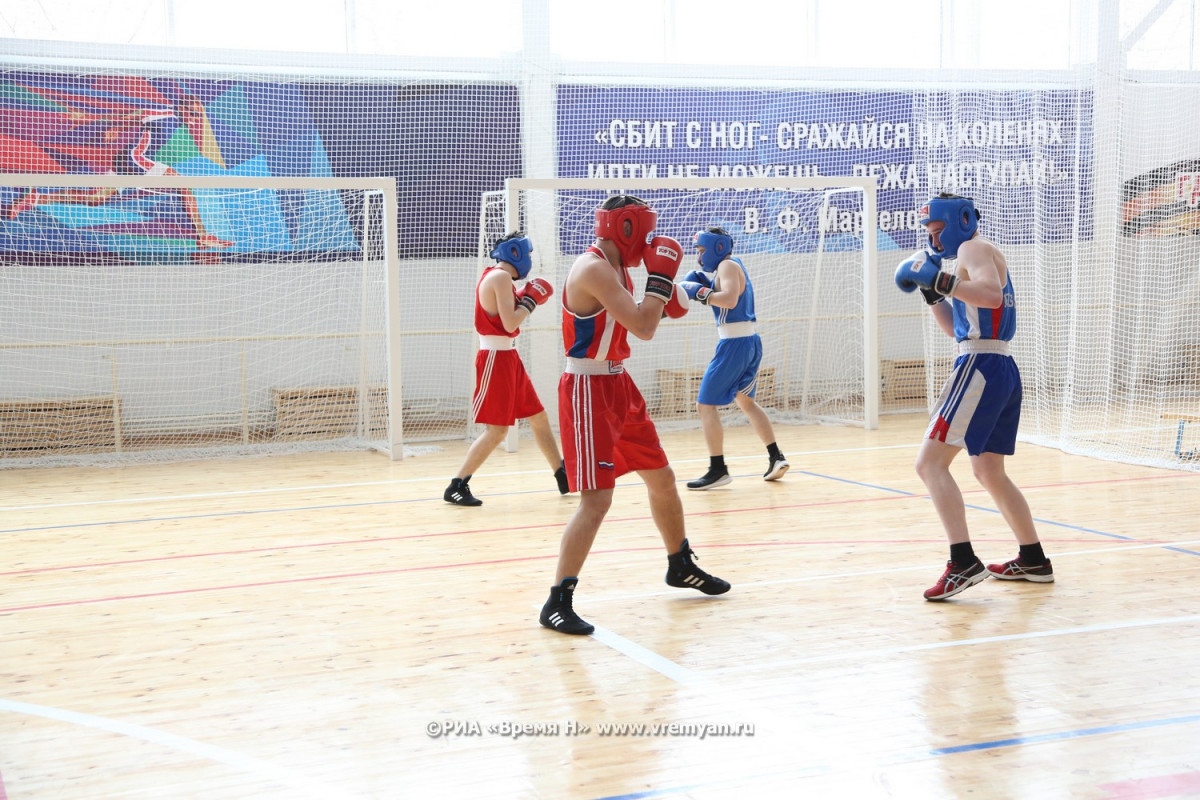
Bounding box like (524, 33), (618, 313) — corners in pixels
(895, 192), (1054, 600)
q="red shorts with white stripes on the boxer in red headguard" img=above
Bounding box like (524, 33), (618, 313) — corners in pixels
(558, 372), (667, 492)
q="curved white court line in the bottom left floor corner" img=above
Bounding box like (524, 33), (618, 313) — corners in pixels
(0, 698), (353, 800)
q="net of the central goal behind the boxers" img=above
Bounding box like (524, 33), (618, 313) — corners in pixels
(470, 178), (880, 438)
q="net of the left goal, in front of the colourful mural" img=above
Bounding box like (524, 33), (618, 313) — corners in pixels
(0, 174), (401, 467)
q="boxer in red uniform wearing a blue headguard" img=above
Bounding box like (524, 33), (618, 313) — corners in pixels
(443, 231), (569, 506)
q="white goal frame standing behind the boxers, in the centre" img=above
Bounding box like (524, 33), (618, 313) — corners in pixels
(480, 176), (881, 450)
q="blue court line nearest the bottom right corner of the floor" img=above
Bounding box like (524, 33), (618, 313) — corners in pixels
(594, 714), (1200, 800)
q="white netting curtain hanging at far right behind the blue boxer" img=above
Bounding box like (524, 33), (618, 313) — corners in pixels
(916, 79), (1200, 469)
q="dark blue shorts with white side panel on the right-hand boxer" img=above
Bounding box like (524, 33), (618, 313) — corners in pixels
(925, 353), (1021, 456)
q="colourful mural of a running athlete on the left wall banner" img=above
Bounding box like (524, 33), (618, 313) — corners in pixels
(0, 73), (359, 260)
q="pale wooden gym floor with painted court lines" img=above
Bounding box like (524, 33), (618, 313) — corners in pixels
(0, 416), (1200, 800)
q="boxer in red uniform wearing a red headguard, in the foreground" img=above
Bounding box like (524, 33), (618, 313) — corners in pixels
(539, 194), (730, 636)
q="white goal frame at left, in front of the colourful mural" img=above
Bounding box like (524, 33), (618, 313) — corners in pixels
(0, 173), (404, 467)
